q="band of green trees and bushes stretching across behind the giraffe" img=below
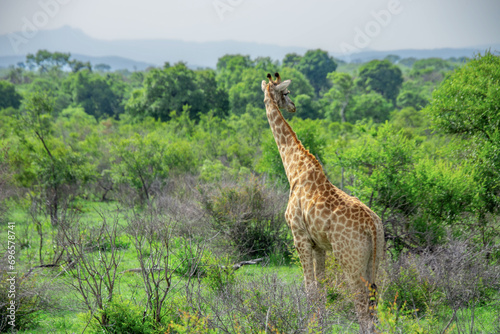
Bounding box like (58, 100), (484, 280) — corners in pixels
(0, 50), (500, 251)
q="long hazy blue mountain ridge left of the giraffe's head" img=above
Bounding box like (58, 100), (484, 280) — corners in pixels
(0, 26), (307, 67)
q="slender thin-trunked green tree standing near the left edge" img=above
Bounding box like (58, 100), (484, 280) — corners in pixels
(14, 93), (93, 225)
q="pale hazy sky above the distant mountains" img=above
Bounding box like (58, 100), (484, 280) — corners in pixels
(0, 0), (500, 52)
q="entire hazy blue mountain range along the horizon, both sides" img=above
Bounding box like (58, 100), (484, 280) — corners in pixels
(0, 26), (500, 70)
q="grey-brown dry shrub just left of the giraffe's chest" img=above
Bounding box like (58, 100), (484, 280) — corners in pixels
(200, 178), (290, 258)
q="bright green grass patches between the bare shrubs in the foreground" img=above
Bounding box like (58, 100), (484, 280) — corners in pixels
(0, 200), (500, 333)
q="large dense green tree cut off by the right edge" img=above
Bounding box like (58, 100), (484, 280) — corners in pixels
(426, 51), (500, 242)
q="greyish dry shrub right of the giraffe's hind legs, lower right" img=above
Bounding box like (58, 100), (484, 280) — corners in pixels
(381, 240), (500, 331)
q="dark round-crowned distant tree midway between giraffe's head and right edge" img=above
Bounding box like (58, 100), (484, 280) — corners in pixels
(357, 60), (403, 102)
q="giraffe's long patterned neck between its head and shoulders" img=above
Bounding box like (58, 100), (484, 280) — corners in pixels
(266, 101), (318, 186)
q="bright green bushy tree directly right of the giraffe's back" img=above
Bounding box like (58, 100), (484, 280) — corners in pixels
(328, 123), (478, 251)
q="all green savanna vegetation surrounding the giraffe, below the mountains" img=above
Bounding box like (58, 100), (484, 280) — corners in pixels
(0, 50), (500, 333)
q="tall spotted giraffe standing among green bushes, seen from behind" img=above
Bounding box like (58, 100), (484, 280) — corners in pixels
(262, 73), (385, 333)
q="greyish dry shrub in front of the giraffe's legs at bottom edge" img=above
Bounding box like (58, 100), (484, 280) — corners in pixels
(194, 273), (352, 334)
